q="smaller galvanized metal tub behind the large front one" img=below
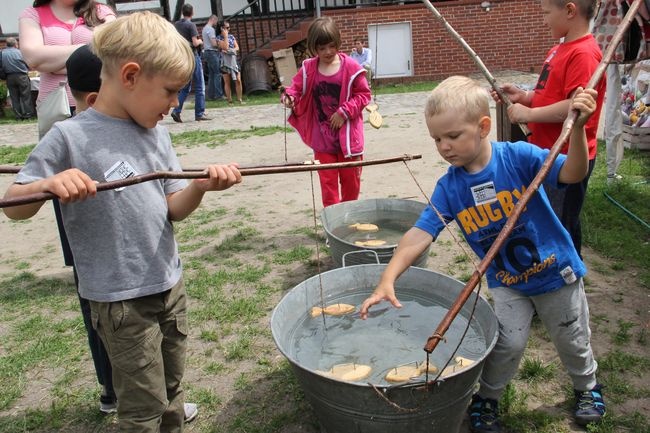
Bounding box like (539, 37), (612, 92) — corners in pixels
(321, 198), (429, 267)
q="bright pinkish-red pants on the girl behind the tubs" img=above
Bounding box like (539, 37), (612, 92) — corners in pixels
(314, 152), (363, 207)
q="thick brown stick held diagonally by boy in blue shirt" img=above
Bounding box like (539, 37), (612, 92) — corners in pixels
(424, 0), (643, 353)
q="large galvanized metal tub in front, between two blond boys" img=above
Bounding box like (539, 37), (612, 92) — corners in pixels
(271, 264), (498, 433)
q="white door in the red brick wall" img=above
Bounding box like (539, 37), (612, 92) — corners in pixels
(368, 22), (413, 78)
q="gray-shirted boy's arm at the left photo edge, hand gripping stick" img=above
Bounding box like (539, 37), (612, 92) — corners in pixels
(3, 168), (97, 220)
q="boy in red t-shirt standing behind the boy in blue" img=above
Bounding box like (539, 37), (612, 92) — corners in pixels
(492, 0), (606, 254)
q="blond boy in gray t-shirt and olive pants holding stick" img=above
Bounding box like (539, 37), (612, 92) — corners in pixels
(4, 12), (241, 433)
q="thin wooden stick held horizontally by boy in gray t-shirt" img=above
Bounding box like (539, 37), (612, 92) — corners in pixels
(0, 155), (422, 208)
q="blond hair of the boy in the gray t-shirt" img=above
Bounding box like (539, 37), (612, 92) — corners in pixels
(92, 11), (194, 82)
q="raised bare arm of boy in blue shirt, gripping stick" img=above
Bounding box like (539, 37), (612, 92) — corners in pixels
(558, 87), (598, 183)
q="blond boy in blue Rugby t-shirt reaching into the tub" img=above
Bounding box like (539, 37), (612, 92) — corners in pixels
(361, 77), (605, 433)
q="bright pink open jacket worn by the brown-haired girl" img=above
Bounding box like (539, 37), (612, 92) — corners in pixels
(286, 53), (371, 158)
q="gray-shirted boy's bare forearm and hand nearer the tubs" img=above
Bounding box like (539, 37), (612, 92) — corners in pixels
(167, 164), (241, 221)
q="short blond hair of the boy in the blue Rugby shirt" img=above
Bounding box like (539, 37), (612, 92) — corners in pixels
(424, 75), (490, 122)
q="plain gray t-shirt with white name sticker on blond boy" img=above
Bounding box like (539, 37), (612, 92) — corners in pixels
(16, 109), (187, 302)
